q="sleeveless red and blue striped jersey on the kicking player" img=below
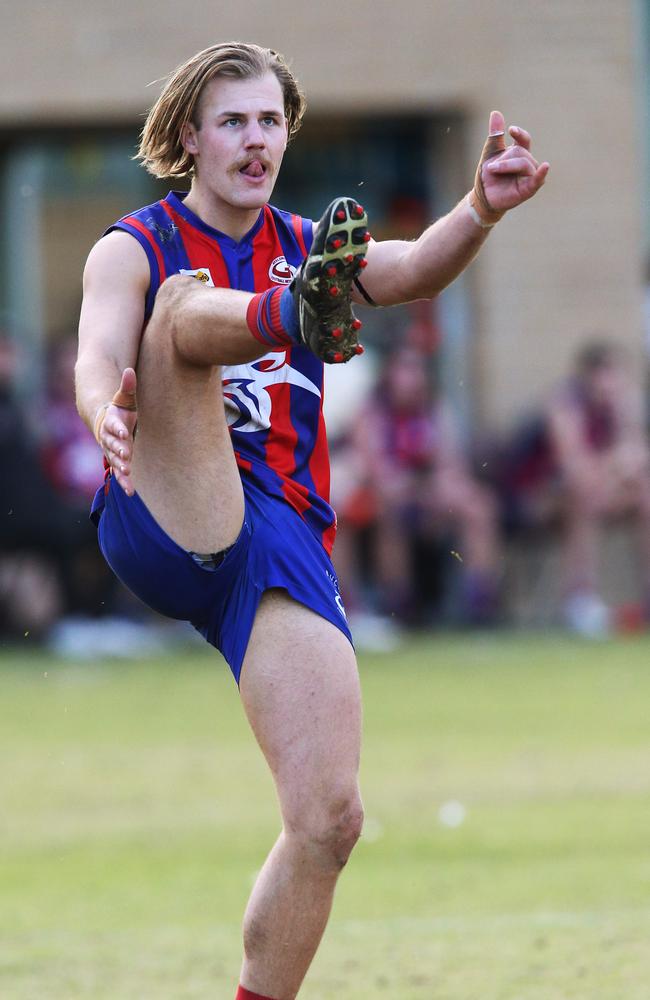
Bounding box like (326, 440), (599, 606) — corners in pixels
(107, 192), (336, 552)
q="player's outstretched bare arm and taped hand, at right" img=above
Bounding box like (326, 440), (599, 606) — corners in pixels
(362, 111), (549, 306)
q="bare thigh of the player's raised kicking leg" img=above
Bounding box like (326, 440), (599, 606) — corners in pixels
(133, 292), (244, 552)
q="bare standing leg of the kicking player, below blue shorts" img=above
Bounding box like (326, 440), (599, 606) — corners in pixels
(241, 590), (363, 1000)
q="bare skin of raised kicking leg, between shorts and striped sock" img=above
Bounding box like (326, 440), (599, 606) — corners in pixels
(132, 277), (263, 552)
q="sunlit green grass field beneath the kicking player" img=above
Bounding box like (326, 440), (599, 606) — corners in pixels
(0, 635), (650, 1000)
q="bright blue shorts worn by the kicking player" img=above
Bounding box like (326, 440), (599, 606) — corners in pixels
(93, 476), (352, 683)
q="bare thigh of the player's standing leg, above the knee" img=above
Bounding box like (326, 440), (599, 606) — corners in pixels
(240, 590), (361, 824)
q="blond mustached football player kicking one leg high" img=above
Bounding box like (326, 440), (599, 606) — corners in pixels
(76, 43), (548, 1000)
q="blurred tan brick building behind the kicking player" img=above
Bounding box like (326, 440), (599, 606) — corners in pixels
(0, 0), (645, 426)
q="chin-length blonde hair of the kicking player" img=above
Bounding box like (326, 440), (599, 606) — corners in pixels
(135, 42), (306, 177)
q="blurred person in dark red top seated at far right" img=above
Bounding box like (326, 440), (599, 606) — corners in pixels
(504, 342), (650, 637)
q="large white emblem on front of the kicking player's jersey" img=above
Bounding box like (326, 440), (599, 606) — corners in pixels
(223, 351), (321, 433)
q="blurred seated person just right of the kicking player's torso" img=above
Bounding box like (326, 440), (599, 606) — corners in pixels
(334, 346), (499, 624)
